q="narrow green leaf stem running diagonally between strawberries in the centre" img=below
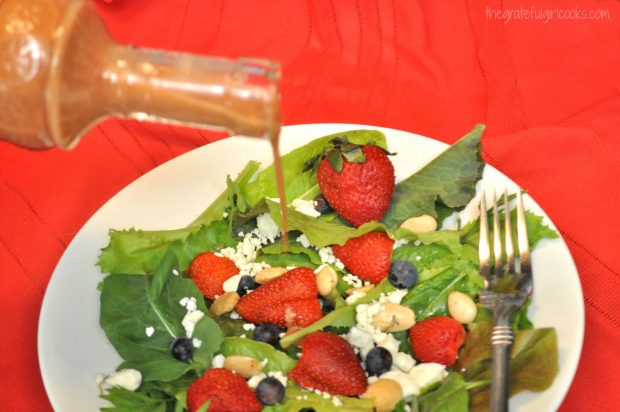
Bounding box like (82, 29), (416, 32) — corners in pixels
(280, 279), (395, 348)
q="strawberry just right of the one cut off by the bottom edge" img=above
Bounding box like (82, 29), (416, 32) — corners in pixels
(289, 332), (368, 396)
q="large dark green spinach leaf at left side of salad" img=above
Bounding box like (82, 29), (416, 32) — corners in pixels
(99, 252), (222, 382)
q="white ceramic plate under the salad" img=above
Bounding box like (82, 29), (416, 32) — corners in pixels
(38, 124), (584, 412)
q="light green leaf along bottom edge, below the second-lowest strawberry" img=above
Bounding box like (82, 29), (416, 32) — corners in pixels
(263, 383), (373, 412)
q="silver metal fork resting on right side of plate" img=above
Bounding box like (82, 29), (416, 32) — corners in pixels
(478, 191), (533, 412)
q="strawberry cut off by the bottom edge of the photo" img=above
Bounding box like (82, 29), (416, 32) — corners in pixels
(187, 369), (263, 412)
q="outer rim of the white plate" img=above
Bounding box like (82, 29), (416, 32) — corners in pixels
(37, 123), (585, 410)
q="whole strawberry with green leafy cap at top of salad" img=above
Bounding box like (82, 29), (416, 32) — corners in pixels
(317, 144), (394, 227)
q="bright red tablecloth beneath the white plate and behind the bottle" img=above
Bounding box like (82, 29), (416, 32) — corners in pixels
(0, 0), (620, 411)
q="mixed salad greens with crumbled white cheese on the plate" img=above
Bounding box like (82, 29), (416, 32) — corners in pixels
(98, 126), (558, 412)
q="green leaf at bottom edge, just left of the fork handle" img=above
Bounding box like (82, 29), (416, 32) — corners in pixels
(418, 373), (469, 412)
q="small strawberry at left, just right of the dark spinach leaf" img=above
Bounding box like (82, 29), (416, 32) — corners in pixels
(189, 252), (239, 299)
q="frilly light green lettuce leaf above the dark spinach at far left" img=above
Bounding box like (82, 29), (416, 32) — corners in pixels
(97, 220), (237, 274)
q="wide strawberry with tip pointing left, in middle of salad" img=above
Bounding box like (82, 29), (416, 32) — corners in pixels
(235, 268), (323, 327)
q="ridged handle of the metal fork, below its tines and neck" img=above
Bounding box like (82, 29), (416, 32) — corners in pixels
(491, 325), (514, 412)
